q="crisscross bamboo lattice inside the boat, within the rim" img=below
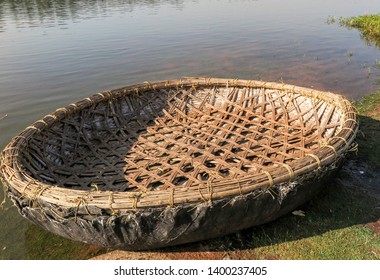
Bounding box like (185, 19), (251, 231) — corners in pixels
(21, 83), (342, 192)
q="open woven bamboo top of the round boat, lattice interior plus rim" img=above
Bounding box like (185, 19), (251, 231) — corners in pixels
(2, 79), (357, 209)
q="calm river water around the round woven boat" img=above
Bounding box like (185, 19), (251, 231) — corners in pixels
(0, 0), (380, 259)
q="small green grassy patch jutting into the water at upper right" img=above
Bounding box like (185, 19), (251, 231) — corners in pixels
(340, 14), (380, 47)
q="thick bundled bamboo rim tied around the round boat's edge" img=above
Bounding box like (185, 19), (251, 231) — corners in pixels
(0, 78), (358, 247)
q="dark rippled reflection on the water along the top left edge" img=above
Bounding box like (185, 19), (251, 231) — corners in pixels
(0, 0), (184, 32)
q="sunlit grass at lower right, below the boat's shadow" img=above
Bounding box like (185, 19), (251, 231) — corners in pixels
(199, 174), (380, 260)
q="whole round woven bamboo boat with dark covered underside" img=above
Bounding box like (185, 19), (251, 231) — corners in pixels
(1, 78), (358, 250)
